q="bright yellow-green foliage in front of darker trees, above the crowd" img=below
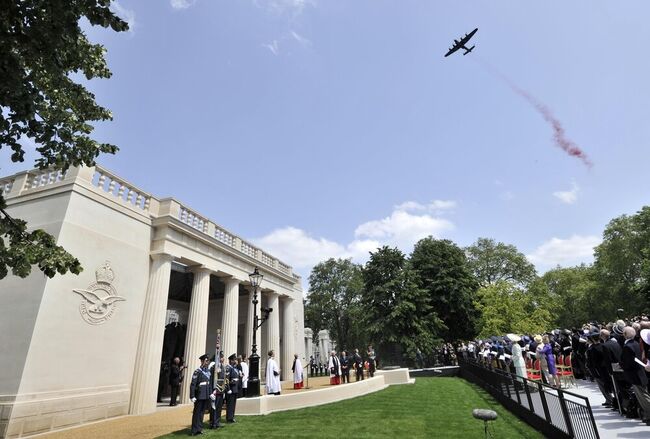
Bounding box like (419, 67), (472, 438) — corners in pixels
(475, 281), (552, 337)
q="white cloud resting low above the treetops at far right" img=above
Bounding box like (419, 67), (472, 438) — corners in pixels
(526, 235), (601, 271)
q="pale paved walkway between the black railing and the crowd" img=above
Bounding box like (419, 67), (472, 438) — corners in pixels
(570, 380), (650, 439)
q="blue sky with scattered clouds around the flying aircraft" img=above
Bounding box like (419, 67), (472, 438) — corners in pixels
(5, 0), (650, 288)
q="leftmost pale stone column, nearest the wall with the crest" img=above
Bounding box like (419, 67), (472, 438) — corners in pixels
(129, 254), (174, 415)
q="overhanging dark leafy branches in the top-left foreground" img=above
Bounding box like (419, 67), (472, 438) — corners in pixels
(0, 0), (128, 278)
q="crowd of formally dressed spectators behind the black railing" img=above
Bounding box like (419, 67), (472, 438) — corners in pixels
(456, 316), (650, 425)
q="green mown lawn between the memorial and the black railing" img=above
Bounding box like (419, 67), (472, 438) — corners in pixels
(158, 378), (543, 439)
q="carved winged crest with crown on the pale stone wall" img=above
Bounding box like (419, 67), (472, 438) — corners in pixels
(72, 261), (126, 325)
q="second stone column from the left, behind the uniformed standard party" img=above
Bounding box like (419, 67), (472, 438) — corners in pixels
(180, 268), (210, 403)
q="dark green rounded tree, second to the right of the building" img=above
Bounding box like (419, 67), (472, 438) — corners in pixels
(361, 246), (442, 362)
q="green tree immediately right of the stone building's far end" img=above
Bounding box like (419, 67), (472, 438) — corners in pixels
(305, 258), (366, 349)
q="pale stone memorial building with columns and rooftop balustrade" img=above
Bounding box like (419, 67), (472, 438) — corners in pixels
(0, 166), (305, 437)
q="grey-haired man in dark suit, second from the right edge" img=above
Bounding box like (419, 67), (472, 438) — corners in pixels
(620, 326), (650, 425)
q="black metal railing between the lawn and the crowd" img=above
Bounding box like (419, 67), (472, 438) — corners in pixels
(459, 359), (600, 439)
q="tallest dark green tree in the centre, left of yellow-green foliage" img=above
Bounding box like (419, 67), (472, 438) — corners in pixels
(410, 236), (478, 340)
